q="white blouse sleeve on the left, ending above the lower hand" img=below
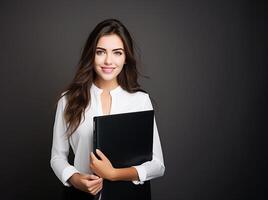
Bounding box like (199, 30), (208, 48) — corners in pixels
(50, 96), (78, 186)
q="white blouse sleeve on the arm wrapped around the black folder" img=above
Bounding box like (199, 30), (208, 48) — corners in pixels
(133, 95), (165, 184)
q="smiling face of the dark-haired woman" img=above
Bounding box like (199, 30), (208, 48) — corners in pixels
(94, 34), (126, 83)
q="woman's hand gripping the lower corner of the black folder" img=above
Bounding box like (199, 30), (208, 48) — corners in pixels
(90, 149), (115, 180)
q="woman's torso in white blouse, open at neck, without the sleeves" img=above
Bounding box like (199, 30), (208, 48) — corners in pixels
(67, 86), (151, 173)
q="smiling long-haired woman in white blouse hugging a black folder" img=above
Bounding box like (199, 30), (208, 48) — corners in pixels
(50, 19), (165, 199)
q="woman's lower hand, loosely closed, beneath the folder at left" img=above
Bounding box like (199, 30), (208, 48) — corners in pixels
(69, 173), (103, 195)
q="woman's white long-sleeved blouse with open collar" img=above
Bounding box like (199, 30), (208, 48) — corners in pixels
(50, 84), (165, 186)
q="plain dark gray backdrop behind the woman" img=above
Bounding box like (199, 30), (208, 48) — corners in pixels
(0, 0), (268, 200)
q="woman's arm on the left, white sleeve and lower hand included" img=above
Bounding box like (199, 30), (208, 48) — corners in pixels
(50, 97), (103, 195)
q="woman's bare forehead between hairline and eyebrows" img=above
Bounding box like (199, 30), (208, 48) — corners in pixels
(97, 34), (124, 49)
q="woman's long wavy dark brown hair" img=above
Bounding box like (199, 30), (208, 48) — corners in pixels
(59, 19), (145, 136)
